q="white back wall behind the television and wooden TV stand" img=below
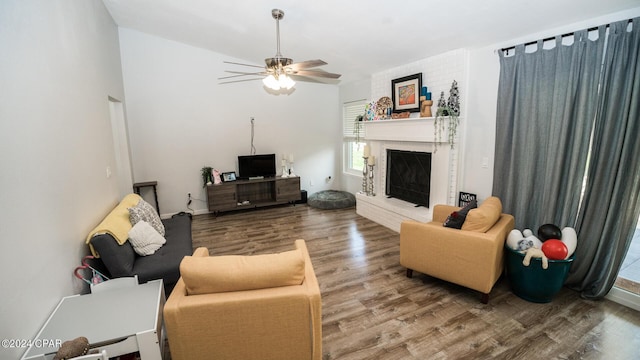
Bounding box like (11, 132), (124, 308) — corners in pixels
(120, 29), (342, 216)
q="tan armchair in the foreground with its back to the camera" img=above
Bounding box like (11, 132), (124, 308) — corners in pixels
(164, 240), (322, 360)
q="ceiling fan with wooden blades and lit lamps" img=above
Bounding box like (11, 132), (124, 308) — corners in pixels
(218, 9), (340, 90)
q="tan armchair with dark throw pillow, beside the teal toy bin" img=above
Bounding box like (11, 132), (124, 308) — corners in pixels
(400, 197), (514, 304)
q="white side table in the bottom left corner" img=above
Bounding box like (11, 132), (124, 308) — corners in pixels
(22, 280), (165, 360)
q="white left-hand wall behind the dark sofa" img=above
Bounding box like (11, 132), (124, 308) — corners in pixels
(0, 0), (124, 359)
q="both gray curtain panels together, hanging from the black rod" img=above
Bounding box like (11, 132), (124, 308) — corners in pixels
(493, 18), (640, 299)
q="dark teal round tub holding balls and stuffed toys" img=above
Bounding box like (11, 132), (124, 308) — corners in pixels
(505, 246), (573, 303)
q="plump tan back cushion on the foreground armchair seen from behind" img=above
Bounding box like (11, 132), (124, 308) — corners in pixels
(180, 249), (305, 295)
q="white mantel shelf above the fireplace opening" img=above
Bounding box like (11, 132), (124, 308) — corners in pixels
(364, 117), (458, 143)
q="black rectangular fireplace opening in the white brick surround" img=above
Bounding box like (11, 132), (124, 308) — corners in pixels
(385, 149), (431, 208)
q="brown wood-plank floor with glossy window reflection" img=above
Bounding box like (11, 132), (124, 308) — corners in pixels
(172, 204), (640, 360)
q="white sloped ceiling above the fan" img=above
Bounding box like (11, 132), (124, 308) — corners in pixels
(103, 0), (640, 82)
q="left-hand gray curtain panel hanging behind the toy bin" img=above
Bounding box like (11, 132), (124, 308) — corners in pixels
(493, 26), (606, 233)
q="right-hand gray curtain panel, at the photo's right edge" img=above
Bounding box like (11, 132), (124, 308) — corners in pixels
(567, 18), (640, 298)
